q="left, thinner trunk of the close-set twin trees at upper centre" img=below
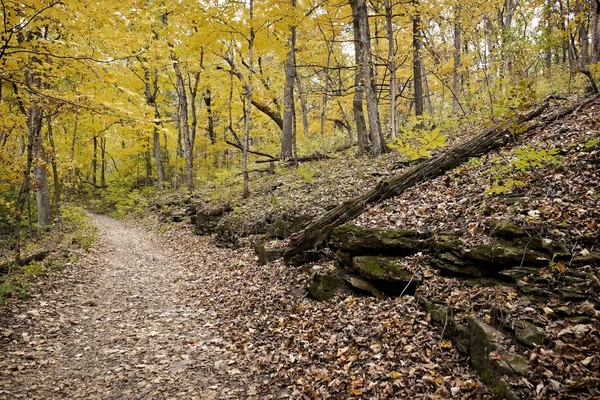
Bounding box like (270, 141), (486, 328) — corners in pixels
(350, 0), (369, 153)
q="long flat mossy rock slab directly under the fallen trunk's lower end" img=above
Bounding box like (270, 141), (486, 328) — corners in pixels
(330, 225), (431, 255)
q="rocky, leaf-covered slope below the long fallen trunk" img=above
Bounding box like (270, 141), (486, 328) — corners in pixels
(304, 97), (600, 398)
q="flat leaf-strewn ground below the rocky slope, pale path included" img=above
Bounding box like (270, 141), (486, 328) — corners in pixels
(0, 215), (486, 399)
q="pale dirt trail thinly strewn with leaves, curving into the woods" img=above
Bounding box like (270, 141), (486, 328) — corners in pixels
(0, 215), (254, 399)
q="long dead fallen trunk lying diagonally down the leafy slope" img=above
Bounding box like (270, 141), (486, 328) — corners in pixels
(284, 95), (599, 261)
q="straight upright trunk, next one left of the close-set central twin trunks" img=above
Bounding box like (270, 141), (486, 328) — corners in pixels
(281, 13), (296, 158)
